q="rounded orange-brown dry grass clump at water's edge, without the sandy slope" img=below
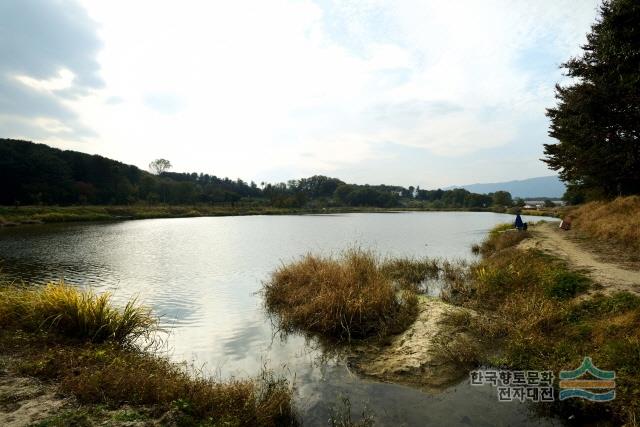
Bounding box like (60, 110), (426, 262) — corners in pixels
(263, 249), (417, 341)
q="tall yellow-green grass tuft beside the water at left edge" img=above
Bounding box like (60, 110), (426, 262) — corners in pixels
(0, 282), (157, 345)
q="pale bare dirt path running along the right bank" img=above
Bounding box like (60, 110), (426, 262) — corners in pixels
(519, 222), (640, 294)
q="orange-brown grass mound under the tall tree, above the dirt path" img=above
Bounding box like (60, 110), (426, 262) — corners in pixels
(567, 196), (640, 251)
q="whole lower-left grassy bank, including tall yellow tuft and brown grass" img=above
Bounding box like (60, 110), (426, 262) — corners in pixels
(0, 284), (298, 426)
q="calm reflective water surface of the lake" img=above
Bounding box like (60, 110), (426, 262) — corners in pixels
(0, 212), (557, 426)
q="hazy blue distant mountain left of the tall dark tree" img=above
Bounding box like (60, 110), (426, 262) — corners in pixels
(445, 176), (566, 199)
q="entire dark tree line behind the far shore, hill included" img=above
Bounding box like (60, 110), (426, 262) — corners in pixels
(0, 139), (512, 209)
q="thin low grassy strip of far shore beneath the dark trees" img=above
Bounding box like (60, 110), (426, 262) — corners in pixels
(0, 203), (561, 227)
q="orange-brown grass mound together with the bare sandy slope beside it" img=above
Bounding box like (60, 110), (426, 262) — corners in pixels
(263, 249), (478, 396)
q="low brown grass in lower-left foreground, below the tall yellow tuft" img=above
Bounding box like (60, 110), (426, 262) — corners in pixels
(0, 333), (298, 426)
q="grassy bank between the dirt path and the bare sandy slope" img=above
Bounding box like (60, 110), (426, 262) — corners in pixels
(445, 224), (640, 425)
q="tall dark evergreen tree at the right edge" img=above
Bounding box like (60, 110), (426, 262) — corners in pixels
(543, 0), (640, 198)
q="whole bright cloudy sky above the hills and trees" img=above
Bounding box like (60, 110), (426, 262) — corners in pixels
(0, 0), (599, 188)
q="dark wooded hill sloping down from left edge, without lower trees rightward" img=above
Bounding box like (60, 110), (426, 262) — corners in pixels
(0, 139), (261, 205)
